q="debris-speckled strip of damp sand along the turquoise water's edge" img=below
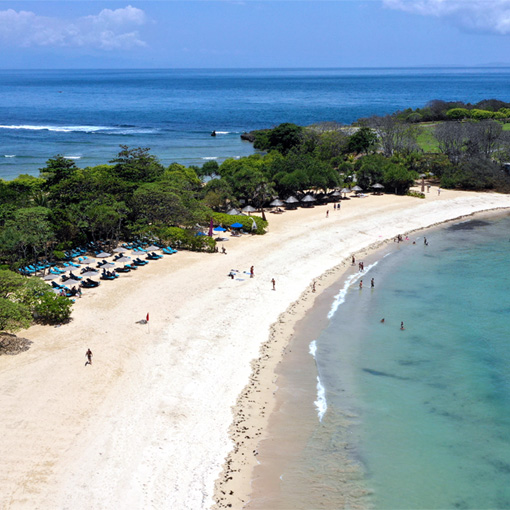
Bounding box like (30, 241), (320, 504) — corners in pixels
(213, 207), (509, 510)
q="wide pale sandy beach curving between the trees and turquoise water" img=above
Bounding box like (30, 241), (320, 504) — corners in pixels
(0, 188), (510, 510)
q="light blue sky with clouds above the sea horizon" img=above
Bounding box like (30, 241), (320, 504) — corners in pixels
(0, 0), (510, 69)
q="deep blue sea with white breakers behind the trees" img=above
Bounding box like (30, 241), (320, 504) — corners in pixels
(0, 68), (510, 179)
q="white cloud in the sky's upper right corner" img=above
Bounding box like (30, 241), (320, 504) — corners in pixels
(383, 0), (510, 35)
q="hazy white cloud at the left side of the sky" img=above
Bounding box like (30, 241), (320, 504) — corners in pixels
(0, 5), (148, 50)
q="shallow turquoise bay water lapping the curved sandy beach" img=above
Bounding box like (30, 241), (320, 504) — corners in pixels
(249, 214), (510, 510)
